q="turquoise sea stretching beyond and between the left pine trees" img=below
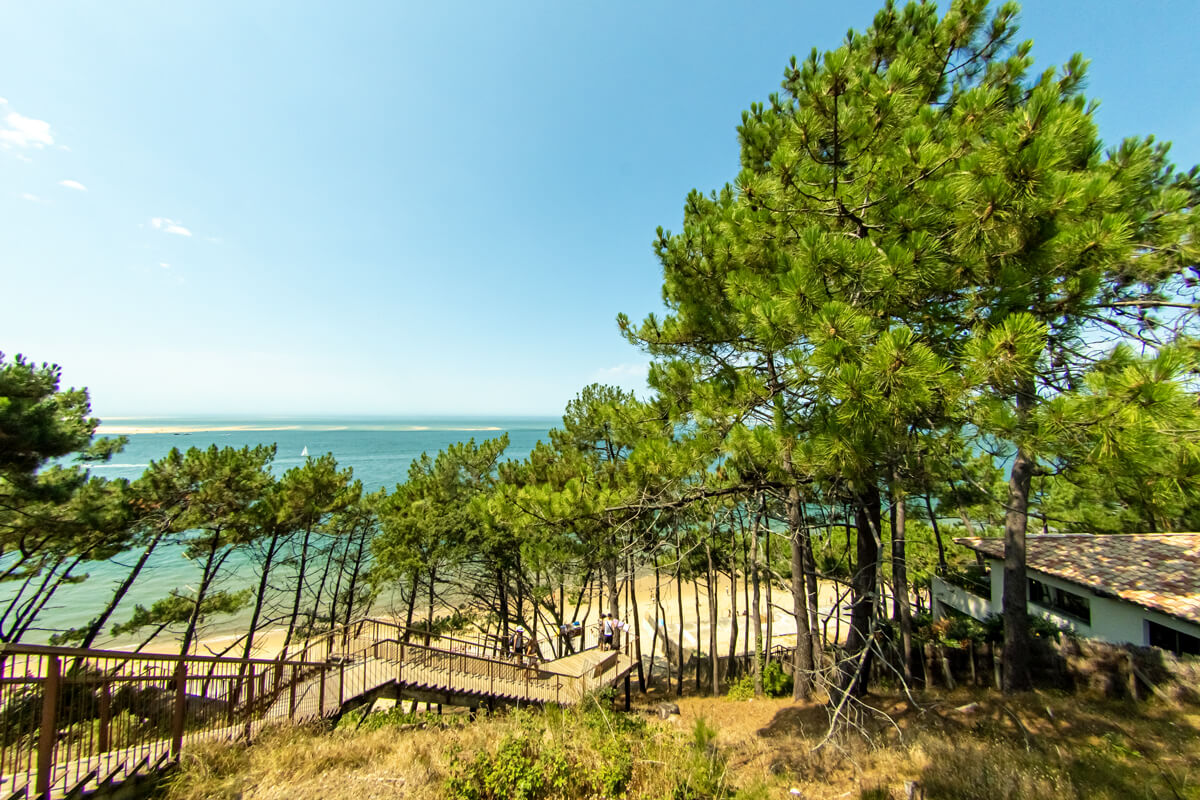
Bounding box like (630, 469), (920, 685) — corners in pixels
(29, 417), (559, 642)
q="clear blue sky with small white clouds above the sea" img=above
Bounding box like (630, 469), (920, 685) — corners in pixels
(0, 0), (1200, 417)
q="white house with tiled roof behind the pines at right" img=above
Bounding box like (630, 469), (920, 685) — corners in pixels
(934, 534), (1200, 655)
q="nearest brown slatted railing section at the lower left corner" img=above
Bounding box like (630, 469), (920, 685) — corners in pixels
(0, 644), (328, 798)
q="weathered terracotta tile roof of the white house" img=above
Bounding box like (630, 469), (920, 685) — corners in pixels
(954, 534), (1200, 624)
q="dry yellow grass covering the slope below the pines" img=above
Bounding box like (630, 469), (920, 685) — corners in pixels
(162, 690), (1200, 800)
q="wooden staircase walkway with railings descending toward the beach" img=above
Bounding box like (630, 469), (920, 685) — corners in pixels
(0, 618), (609, 800)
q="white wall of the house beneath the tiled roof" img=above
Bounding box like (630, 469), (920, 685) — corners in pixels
(934, 559), (1200, 645)
